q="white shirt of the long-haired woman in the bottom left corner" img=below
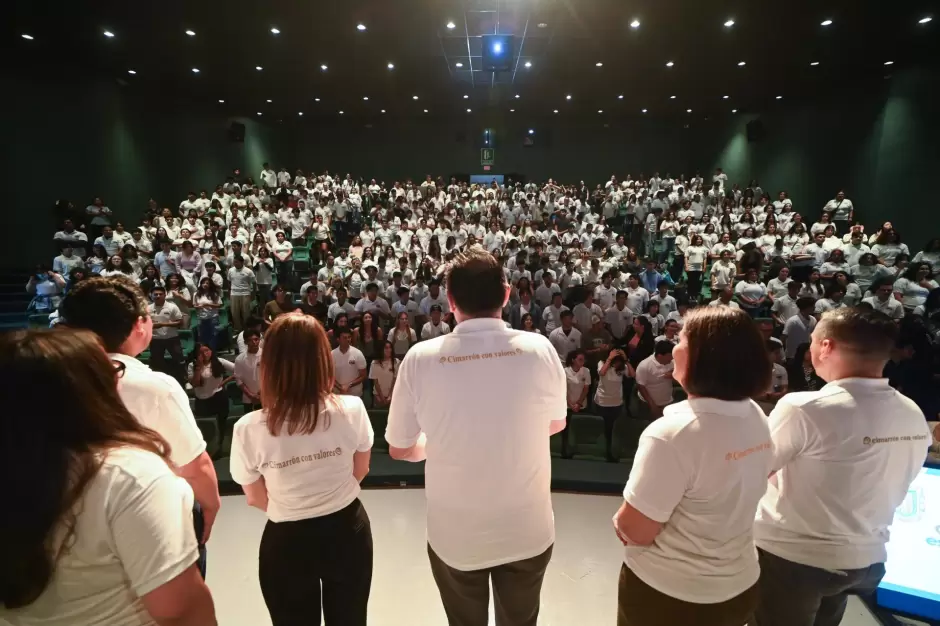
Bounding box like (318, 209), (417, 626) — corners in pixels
(0, 448), (199, 626)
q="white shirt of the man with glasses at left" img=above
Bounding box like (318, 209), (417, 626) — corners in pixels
(110, 354), (206, 467)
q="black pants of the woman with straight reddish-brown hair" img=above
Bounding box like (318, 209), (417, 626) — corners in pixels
(258, 499), (372, 626)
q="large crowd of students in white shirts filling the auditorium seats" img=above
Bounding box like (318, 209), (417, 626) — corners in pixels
(42, 165), (940, 428)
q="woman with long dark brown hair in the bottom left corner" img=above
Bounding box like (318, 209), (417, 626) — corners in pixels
(0, 329), (216, 626)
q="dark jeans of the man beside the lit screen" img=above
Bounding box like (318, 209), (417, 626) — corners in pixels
(751, 548), (885, 626)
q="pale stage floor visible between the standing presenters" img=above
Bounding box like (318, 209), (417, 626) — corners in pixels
(208, 489), (896, 626)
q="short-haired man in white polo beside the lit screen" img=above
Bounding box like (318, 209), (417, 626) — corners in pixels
(752, 307), (931, 626)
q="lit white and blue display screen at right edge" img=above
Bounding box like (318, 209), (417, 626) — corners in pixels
(876, 467), (940, 619)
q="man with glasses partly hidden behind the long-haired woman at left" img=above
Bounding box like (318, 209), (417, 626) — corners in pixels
(59, 277), (222, 576)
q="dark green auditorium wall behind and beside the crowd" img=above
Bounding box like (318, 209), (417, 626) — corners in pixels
(7, 67), (940, 267)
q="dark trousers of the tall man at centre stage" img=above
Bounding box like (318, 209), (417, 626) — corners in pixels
(428, 544), (554, 626)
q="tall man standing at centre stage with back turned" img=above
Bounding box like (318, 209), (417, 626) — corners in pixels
(385, 248), (567, 625)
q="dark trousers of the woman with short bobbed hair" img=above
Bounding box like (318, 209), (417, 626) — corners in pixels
(617, 564), (760, 626)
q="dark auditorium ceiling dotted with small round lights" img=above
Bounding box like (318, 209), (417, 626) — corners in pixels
(12, 0), (940, 119)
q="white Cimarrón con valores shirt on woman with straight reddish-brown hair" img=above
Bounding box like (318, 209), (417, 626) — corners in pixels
(230, 395), (373, 522)
